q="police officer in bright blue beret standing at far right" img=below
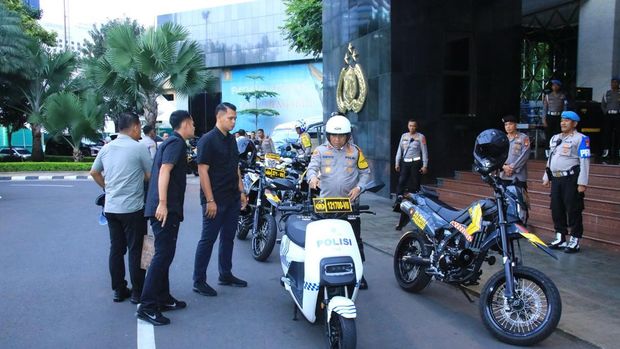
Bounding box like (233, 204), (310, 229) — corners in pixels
(543, 111), (590, 253)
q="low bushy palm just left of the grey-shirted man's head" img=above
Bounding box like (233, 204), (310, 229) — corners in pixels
(43, 90), (105, 162)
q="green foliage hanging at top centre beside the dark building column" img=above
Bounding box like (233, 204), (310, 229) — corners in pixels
(280, 0), (323, 57)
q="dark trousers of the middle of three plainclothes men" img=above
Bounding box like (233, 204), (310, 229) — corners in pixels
(140, 213), (181, 310)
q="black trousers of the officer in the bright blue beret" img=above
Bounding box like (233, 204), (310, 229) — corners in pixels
(551, 173), (585, 238)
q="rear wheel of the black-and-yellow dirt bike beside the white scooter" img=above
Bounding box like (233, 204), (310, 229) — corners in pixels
(394, 230), (431, 293)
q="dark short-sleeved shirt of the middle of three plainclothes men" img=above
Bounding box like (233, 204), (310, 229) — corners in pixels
(144, 132), (187, 221)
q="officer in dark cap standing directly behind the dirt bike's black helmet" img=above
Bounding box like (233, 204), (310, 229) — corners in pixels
(499, 115), (530, 189)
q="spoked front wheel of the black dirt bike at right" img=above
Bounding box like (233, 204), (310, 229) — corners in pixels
(480, 266), (562, 346)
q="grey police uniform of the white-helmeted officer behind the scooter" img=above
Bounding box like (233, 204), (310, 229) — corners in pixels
(307, 142), (370, 261)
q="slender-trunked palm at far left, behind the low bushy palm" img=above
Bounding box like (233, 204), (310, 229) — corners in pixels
(22, 49), (77, 161)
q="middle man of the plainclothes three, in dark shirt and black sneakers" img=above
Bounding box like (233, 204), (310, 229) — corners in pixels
(136, 110), (194, 326)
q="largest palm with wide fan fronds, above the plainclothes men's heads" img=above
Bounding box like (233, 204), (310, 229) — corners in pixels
(90, 23), (211, 126)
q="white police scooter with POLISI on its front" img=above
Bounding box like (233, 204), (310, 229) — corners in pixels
(278, 184), (383, 349)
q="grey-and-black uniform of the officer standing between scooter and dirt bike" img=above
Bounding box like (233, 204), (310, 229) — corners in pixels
(394, 132), (428, 195)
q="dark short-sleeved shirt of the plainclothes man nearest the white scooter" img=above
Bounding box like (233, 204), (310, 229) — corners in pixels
(197, 127), (240, 205)
